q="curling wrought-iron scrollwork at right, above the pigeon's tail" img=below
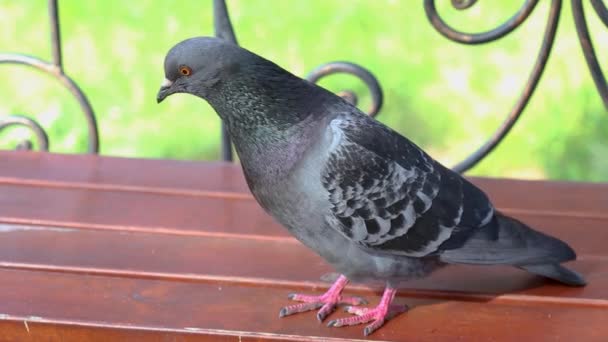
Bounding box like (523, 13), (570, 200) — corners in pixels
(424, 0), (608, 173)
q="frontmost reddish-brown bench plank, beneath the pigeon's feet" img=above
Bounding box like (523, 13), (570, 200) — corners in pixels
(0, 270), (608, 341)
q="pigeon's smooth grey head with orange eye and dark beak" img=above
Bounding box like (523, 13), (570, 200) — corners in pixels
(156, 37), (247, 103)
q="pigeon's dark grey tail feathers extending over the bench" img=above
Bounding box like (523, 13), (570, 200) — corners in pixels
(440, 212), (585, 286)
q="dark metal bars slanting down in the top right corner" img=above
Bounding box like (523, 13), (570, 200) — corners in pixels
(571, 0), (608, 109)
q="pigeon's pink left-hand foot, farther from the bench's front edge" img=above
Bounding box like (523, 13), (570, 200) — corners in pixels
(279, 275), (366, 321)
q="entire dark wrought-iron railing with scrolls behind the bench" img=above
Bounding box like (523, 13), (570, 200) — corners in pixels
(0, 0), (608, 172)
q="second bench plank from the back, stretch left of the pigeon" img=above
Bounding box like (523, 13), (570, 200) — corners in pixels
(0, 184), (287, 237)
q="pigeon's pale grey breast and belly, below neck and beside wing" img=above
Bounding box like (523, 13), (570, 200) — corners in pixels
(244, 117), (446, 282)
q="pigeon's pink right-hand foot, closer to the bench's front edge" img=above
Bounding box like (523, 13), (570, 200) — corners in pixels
(327, 287), (408, 336)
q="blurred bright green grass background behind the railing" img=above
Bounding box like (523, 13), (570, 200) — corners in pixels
(0, 0), (608, 181)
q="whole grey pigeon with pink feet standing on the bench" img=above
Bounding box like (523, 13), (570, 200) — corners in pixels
(157, 37), (586, 335)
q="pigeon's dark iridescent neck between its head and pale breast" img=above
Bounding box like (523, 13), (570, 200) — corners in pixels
(208, 72), (328, 187)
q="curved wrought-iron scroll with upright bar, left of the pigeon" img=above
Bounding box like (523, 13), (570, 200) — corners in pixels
(0, 0), (99, 153)
